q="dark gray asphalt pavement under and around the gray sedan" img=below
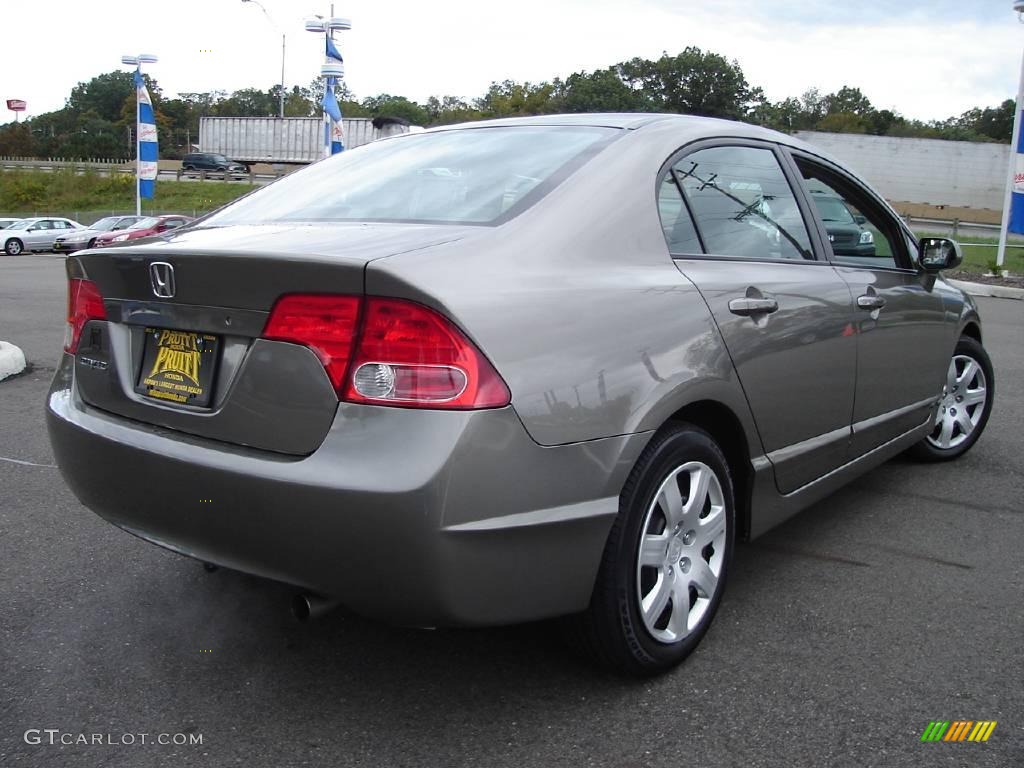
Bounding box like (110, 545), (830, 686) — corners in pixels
(0, 255), (1024, 768)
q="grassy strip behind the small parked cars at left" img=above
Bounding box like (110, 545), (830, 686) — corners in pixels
(0, 170), (253, 224)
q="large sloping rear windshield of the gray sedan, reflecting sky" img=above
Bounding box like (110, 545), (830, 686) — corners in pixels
(204, 126), (621, 226)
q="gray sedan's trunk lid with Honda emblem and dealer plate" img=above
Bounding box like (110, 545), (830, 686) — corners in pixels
(68, 224), (464, 455)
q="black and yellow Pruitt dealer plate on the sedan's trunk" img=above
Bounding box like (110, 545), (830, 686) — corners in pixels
(135, 328), (219, 407)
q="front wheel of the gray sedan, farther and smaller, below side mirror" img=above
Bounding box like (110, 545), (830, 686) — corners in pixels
(909, 336), (995, 462)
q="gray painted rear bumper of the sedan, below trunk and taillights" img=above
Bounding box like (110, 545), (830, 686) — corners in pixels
(46, 355), (649, 626)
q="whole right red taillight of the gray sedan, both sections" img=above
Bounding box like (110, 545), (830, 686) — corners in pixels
(263, 295), (511, 410)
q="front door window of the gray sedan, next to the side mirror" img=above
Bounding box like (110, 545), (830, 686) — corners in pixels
(796, 157), (909, 269)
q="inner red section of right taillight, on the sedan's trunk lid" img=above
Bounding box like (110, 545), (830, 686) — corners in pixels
(263, 294), (361, 391)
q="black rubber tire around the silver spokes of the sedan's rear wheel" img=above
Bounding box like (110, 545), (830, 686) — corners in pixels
(568, 423), (735, 677)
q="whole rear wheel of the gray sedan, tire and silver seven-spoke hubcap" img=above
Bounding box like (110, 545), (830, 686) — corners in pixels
(572, 424), (735, 676)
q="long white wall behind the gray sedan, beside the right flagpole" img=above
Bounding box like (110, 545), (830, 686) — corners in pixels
(796, 131), (1010, 210)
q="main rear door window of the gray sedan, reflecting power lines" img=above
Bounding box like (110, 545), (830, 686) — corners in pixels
(672, 146), (814, 260)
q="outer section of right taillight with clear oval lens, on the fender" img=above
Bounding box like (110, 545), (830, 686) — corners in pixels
(342, 297), (511, 409)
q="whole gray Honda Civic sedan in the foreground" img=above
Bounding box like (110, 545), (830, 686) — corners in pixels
(47, 115), (994, 675)
